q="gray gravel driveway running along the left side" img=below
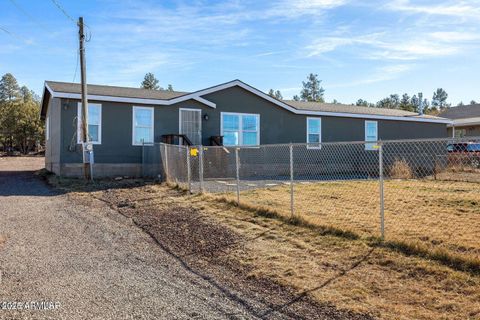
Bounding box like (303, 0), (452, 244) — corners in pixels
(0, 158), (264, 319)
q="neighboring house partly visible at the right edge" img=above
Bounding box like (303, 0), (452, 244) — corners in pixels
(439, 104), (480, 138)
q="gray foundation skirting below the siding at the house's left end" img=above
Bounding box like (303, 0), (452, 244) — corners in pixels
(57, 163), (142, 178)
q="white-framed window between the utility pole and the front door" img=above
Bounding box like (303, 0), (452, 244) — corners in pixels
(132, 107), (154, 146)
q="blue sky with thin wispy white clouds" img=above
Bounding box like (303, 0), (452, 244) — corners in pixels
(0, 0), (480, 104)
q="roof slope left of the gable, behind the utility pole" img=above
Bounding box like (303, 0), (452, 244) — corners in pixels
(45, 81), (188, 100)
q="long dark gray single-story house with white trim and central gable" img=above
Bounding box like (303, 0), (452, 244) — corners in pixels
(41, 80), (449, 176)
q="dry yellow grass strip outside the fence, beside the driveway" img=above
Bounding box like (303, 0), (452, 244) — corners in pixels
(158, 186), (480, 319)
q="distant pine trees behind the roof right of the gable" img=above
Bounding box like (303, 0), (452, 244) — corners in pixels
(268, 73), (476, 114)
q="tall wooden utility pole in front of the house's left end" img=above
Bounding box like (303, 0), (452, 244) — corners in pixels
(78, 17), (91, 180)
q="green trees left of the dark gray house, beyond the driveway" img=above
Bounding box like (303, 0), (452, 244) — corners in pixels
(0, 73), (45, 154)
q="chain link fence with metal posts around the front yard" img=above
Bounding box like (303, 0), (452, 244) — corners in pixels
(144, 138), (480, 261)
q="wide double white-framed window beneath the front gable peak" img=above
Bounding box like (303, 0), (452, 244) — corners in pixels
(220, 112), (260, 146)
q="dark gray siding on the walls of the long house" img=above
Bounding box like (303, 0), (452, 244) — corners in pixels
(58, 87), (447, 163)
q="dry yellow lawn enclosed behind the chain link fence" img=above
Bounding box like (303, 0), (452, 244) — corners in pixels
(229, 180), (480, 266)
